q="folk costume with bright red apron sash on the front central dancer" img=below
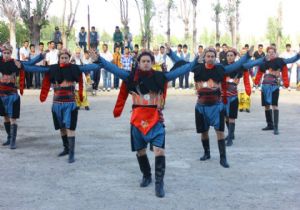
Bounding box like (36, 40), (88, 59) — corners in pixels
(99, 52), (195, 197)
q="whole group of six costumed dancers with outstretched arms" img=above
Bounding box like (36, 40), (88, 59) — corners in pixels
(0, 43), (300, 197)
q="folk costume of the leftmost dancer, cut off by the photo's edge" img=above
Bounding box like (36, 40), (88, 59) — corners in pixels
(0, 43), (43, 149)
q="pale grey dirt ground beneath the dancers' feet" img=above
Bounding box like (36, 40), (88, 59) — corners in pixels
(0, 90), (300, 210)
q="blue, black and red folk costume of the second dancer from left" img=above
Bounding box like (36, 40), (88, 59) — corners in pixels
(26, 51), (99, 163)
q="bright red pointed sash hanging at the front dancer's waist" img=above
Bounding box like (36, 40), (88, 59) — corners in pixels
(130, 107), (159, 135)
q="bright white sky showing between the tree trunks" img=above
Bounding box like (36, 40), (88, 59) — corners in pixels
(5, 0), (300, 45)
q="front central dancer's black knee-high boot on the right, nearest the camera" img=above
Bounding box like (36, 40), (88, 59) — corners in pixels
(155, 156), (166, 198)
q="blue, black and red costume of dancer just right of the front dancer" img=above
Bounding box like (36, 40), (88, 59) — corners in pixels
(169, 48), (254, 168)
